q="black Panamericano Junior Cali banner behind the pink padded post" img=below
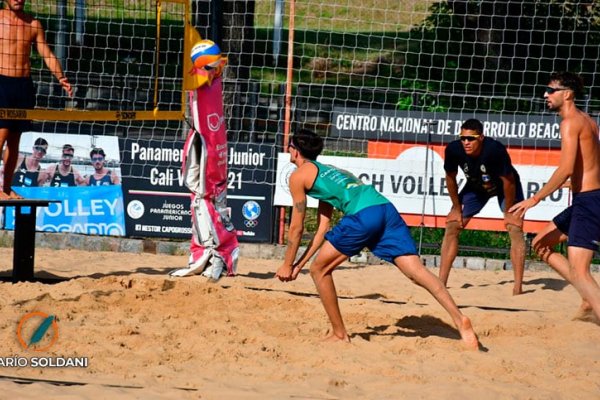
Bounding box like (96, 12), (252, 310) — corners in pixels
(121, 139), (275, 243)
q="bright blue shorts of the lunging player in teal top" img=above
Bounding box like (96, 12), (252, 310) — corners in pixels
(325, 203), (417, 263)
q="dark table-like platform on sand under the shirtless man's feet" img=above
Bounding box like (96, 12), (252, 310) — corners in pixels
(0, 199), (60, 282)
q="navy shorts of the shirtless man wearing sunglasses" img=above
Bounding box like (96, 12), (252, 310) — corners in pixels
(552, 189), (600, 251)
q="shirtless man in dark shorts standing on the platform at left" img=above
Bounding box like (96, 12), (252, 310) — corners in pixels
(0, 0), (73, 199)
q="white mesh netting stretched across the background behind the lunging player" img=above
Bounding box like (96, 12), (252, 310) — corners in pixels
(1, 0), (600, 244)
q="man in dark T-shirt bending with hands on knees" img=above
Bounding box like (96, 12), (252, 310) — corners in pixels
(440, 119), (525, 295)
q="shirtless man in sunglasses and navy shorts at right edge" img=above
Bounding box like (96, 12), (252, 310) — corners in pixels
(509, 72), (600, 323)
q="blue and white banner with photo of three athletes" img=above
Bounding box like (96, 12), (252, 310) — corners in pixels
(2, 132), (125, 236)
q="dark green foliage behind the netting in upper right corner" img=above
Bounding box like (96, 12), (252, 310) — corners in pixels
(404, 0), (600, 112)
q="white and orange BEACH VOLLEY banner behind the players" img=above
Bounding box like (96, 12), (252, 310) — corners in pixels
(274, 143), (570, 231)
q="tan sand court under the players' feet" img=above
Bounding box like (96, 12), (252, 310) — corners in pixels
(0, 248), (600, 399)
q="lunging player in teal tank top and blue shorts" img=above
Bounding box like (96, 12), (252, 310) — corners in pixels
(275, 130), (479, 349)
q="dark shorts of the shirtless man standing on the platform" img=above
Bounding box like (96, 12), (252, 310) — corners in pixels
(0, 75), (35, 132)
